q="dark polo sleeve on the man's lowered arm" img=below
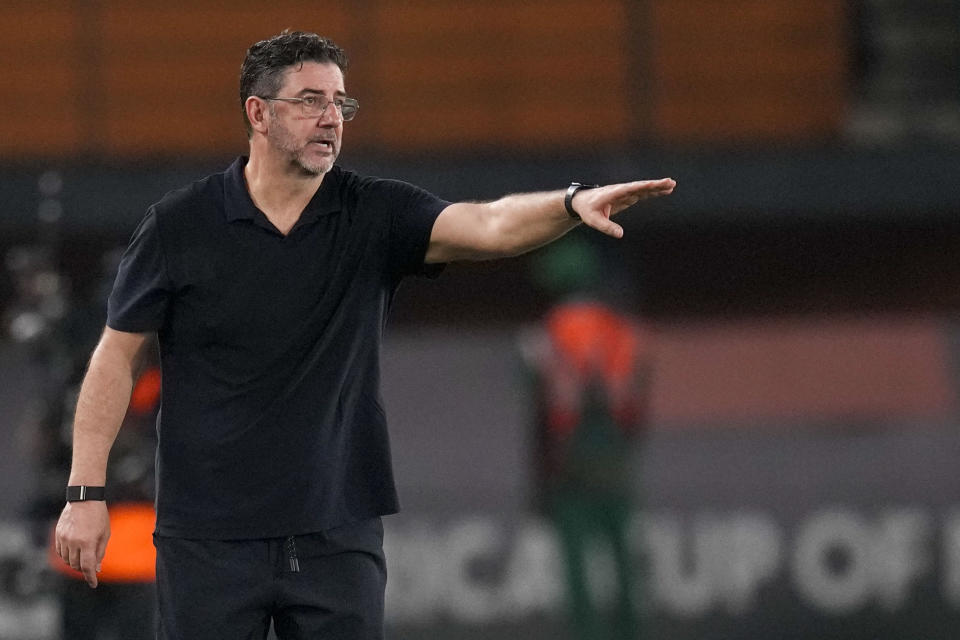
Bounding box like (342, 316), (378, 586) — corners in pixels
(107, 208), (172, 333)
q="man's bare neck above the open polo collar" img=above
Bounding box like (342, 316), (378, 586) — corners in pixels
(243, 150), (325, 234)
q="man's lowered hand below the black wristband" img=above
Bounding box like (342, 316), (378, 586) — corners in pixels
(56, 500), (110, 589)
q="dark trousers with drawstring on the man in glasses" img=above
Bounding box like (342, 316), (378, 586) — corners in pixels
(154, 518), (387, 640)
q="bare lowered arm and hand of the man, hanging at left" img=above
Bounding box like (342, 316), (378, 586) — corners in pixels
(56, 327), (151, 587)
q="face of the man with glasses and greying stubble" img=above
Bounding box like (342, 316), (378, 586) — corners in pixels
(267, 62), (347, 176)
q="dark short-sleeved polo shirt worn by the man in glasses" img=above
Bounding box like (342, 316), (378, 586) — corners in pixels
(107, 158), (449, 539)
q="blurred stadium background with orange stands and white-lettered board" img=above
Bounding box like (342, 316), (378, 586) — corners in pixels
(0, 0), (960, 640)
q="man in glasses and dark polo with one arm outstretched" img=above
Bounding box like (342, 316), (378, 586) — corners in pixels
(56, 32), (674, 640)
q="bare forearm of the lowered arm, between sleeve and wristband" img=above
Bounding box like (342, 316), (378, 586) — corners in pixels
(69, 336), (143, 486)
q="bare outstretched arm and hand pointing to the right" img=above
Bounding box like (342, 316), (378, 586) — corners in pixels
(426, 178), (676, 263)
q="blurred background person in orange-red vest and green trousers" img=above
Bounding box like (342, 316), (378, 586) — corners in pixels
(520, 233), (652, 640)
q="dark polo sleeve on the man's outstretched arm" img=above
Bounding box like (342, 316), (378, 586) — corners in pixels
(382, 180), (450, 276)
